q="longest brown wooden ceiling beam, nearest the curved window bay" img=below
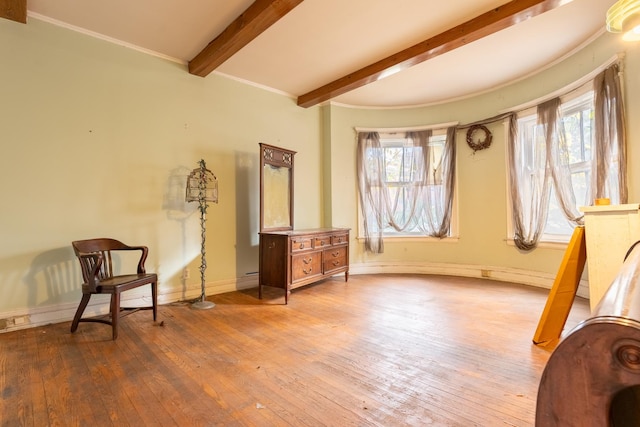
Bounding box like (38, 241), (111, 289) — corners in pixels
(298, 0), (566, 108)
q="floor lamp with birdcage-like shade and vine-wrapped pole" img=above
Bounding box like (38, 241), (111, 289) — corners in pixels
(186, 159), (218, 310)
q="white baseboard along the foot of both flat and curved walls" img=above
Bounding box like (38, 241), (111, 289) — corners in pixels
(0, 268), (589, 333)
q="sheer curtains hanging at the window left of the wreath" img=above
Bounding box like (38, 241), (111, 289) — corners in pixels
(357, 127), (456, 253)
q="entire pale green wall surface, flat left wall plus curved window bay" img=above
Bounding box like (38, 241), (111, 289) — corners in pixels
(0, 15), (640, 330)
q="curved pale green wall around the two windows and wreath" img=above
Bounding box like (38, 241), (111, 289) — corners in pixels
(325, 34), (640, 277)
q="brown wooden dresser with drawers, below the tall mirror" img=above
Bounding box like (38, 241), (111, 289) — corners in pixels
(258, 228), (349, 304)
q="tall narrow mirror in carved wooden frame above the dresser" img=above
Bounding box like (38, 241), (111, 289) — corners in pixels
(260, 143), (296, 232)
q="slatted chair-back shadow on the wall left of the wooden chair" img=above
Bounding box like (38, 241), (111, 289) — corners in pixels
(24, 246), (82, 307)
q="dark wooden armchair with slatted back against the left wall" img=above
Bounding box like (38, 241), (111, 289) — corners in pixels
(71, 238), (158, 340)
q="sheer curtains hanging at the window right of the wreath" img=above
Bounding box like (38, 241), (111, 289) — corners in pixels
(507, 64), (627, 251)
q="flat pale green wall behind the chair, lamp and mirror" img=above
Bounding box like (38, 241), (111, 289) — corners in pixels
(0, 19), (322, 318)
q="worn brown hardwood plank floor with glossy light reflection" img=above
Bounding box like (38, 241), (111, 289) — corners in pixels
(0, 275), (589, 426)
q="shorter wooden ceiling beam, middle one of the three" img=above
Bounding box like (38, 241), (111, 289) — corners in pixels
(189, 0), (303, 77)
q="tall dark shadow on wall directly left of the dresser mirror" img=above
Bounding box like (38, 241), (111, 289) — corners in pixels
(236, 149), (260, 278)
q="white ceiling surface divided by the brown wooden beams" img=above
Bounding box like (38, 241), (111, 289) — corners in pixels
(27, 0), (615, 107)
